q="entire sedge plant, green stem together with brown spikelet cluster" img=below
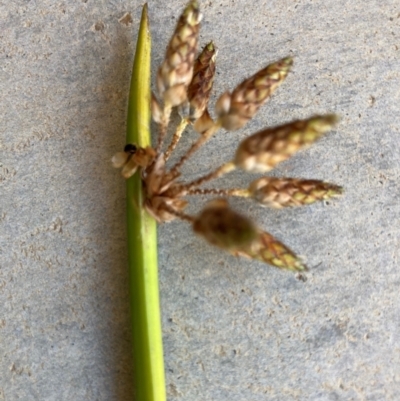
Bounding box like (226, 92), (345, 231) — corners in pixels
(112, 0), (342, 401)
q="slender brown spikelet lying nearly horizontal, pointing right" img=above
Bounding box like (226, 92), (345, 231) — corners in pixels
(249, 177), (342, 208)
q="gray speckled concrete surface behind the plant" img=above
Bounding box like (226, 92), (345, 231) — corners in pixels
(0, 0), (400, 401)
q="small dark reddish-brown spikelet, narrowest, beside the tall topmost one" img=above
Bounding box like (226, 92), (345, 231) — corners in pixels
(187, 42), (217, 121)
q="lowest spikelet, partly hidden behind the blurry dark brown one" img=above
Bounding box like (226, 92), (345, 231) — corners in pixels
(238, 231), (307, 271)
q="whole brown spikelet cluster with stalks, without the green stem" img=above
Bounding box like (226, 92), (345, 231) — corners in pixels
(112, 1), (342, 271)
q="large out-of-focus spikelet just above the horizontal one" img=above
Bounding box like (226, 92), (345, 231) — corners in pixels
(234, 114), (337, 173)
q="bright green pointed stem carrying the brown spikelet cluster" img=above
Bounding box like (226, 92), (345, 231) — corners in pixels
(126, 5), (166, 401)
